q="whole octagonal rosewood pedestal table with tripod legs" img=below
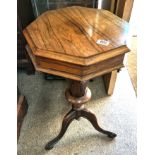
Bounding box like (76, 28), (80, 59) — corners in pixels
(23, 6), (129, 150)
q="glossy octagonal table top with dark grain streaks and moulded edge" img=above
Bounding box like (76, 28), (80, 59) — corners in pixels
(23, 6), (129, 66)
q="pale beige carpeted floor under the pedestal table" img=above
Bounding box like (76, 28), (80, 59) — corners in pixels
(18, 69), (137, 155)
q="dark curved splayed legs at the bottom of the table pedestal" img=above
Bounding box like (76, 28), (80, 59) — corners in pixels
(45, 109), (117, 150)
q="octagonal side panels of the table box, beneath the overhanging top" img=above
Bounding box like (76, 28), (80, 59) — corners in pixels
(26, 46), (124, 81)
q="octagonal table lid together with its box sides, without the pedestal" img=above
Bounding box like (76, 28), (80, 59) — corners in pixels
(23, 7), (129, 81)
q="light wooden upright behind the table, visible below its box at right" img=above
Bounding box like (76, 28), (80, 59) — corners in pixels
(103, 70), (117, 95)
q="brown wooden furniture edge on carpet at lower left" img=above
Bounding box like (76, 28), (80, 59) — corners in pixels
(17, 87), (28, 141)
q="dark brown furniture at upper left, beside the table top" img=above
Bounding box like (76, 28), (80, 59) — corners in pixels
(17, 0), (35, 74)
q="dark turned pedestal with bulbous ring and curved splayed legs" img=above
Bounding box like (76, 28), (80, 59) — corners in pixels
(45, 81), (116, 150)
